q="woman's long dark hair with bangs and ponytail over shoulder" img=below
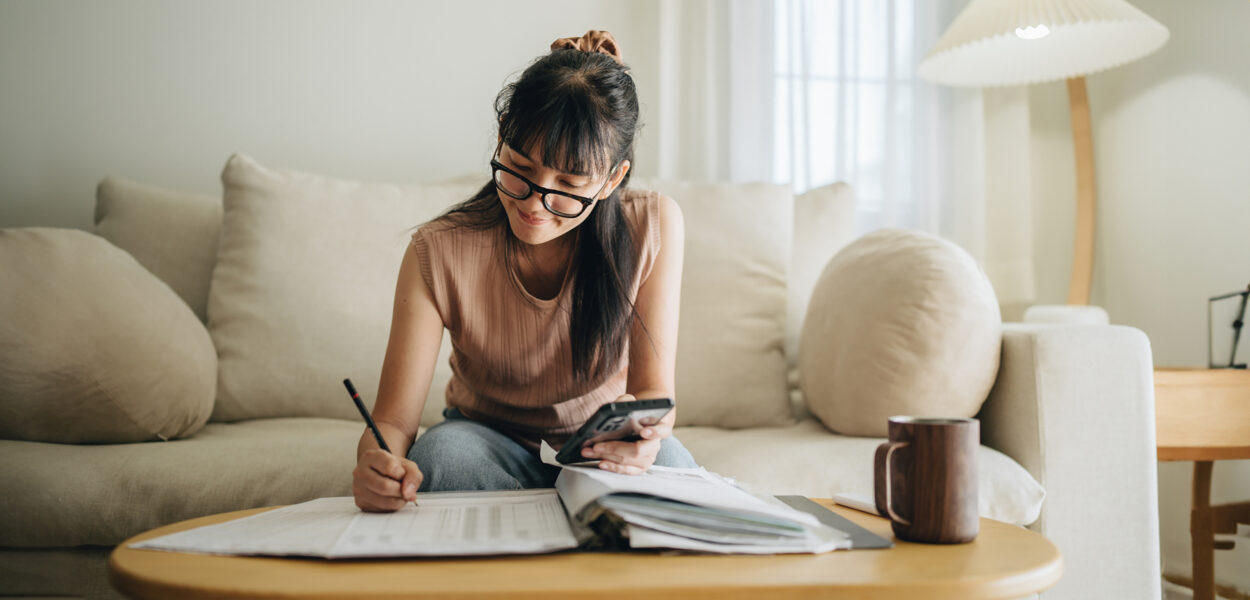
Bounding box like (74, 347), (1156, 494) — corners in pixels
(440, 49), (639, 381)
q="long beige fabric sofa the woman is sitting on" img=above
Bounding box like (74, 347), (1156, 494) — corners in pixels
(0, 155), (1160, 599)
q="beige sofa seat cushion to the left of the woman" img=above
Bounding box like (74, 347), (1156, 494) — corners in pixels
(0, 417), (364, 548)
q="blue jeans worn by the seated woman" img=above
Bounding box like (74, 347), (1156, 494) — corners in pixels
(408, 409), (699, 491)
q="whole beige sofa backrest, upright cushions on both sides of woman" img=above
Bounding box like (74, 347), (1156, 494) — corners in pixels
(96, 156), (854, 428)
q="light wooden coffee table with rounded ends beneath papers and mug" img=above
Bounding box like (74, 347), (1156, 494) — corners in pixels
(109, 500), (1063, 600)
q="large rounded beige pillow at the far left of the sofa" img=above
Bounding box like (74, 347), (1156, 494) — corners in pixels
(0, 228), (218, 442)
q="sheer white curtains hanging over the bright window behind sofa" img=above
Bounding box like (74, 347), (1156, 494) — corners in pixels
(659, 0), (1034, 305)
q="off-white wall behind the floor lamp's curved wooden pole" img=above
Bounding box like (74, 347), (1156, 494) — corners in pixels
(1030, 0), (1250, 590)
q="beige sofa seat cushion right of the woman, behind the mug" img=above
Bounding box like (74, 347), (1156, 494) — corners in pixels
(674, 419), (1046, 525)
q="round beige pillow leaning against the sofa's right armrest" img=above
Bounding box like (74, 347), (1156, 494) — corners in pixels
(799, 229), (1003, 436)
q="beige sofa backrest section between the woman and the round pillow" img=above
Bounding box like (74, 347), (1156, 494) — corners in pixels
(630, 179), (855, 428)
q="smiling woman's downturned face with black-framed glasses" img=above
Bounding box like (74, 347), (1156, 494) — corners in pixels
(495, 144), (629, 246)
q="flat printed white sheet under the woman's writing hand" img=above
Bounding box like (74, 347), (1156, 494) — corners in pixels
(133, 489), (578, 559)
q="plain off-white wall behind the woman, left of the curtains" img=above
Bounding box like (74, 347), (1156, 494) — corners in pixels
(0, 0), (658, 228)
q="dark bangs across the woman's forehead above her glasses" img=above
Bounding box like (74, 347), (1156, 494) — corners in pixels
(500, 80), (615, 176)
